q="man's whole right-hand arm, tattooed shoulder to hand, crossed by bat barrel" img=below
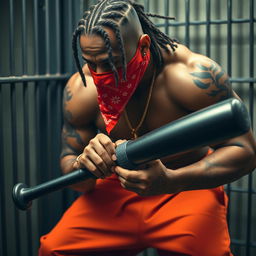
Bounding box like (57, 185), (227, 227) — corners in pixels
(113, 57), (256, 195)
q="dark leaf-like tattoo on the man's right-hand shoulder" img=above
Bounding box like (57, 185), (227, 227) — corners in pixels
(190, 62), (231, 100)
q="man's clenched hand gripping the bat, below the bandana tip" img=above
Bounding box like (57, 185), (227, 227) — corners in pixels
(73, 133), (116, 179)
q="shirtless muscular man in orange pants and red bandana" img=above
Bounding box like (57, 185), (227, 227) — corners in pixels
(39, 0), (256, 256)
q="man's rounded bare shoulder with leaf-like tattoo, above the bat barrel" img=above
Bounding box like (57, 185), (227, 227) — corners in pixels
(163, 45), (231, 111)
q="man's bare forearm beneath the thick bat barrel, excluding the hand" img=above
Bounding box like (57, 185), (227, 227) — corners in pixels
(171, 146), (256, 191)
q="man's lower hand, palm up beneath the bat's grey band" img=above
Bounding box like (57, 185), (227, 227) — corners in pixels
(114, 160), (181, 196)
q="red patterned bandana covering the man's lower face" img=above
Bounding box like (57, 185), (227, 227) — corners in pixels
(89, 40), (150, 134)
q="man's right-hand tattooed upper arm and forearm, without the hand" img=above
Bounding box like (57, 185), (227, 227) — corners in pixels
(175, 58), (256, 190)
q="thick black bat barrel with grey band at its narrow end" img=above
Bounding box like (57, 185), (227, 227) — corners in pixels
(116, 98), (250, 169)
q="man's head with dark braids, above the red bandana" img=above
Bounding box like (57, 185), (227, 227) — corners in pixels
(72, 0), (176, 84)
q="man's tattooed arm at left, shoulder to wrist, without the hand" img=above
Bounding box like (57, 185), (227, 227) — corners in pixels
(60, 75), (97, 192)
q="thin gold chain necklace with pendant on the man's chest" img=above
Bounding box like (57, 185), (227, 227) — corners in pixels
(124, 70), (156, 139)
